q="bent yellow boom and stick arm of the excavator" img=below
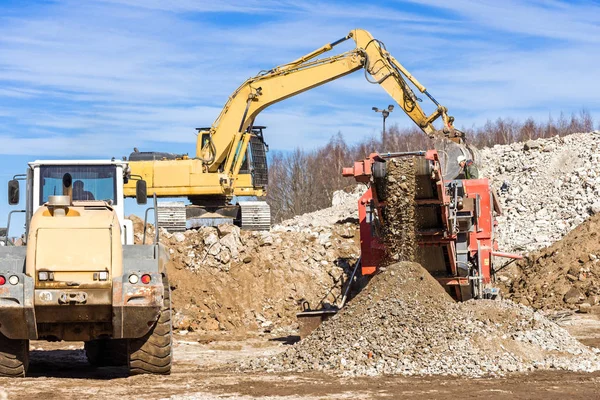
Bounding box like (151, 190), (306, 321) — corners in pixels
(196, 29), (460, 175)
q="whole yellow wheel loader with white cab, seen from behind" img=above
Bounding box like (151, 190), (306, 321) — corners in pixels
(0, 160), (172, 377)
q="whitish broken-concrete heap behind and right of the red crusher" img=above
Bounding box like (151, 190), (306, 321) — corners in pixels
(479, 131), (600, 251)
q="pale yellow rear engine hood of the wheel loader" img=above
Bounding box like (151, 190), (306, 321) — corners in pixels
(26, 201), (123, 288)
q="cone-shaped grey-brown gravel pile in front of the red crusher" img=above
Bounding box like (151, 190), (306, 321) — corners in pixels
(247, 262), (600, 377)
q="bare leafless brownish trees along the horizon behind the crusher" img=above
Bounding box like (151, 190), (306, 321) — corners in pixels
(267, 110), (594, 222)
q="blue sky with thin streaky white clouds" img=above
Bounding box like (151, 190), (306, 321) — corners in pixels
(0, 0), (600, 230)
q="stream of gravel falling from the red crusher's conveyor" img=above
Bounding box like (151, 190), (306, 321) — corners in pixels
(383, 157), (416, 261)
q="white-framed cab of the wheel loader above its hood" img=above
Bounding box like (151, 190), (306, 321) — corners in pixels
(9, 160), (139, 244)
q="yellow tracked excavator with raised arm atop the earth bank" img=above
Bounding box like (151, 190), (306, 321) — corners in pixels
(124, 29), (463, 230)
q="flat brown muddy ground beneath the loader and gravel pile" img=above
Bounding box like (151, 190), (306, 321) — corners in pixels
(0, 314), (600, 400)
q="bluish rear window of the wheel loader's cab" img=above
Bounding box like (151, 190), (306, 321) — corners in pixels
(40, 165), (117, 205)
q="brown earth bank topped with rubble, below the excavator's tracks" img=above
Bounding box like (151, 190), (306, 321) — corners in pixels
(130, 216), (360, 332)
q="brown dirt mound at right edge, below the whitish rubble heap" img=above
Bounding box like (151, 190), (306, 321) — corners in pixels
(500, 214), (600, 309)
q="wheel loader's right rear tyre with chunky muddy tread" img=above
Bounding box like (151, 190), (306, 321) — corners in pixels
(128, 277), (173, 375)
